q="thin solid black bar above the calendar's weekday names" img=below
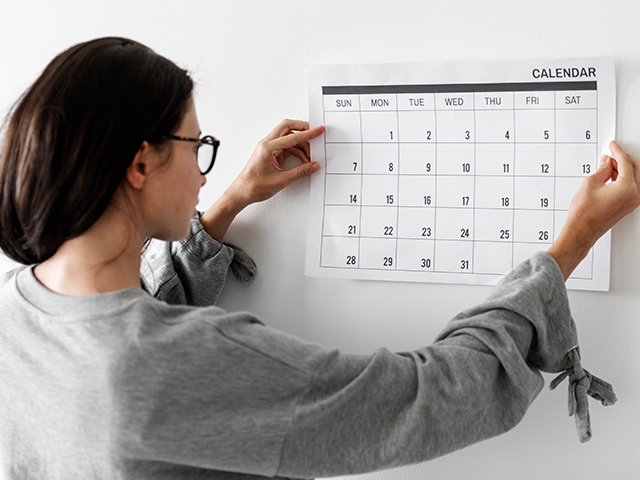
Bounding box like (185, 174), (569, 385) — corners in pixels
(322, 81), (598, 95)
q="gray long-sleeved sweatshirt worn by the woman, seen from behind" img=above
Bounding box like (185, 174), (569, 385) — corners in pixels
(0, 219), (577, 480)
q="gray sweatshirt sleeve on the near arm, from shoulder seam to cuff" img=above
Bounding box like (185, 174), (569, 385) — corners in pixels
(278, 253), (577, 477)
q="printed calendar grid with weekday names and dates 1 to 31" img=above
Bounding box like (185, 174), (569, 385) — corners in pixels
(319, 82), (598, 278)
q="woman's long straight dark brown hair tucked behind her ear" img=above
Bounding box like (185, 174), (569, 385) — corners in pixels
(0, 38), (193, 264)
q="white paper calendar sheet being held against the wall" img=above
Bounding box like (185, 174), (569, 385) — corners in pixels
(305, 58), (615, 290)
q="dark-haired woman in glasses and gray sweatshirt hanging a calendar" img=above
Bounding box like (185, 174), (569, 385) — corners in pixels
(0, 38), (640, 479)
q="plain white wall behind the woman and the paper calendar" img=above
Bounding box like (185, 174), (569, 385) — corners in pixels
(0, 0), (640, 480)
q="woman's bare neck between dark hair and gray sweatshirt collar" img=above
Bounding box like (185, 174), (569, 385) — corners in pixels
(34, 201), (144, 296)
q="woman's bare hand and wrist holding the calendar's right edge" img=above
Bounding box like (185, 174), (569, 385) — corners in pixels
(549, 141), (640, 280)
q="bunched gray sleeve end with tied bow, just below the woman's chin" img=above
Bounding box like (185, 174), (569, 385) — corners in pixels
(140, 217), (257, 306)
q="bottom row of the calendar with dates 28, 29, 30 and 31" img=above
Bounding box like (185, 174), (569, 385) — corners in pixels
(321, 237), (593, 279)
